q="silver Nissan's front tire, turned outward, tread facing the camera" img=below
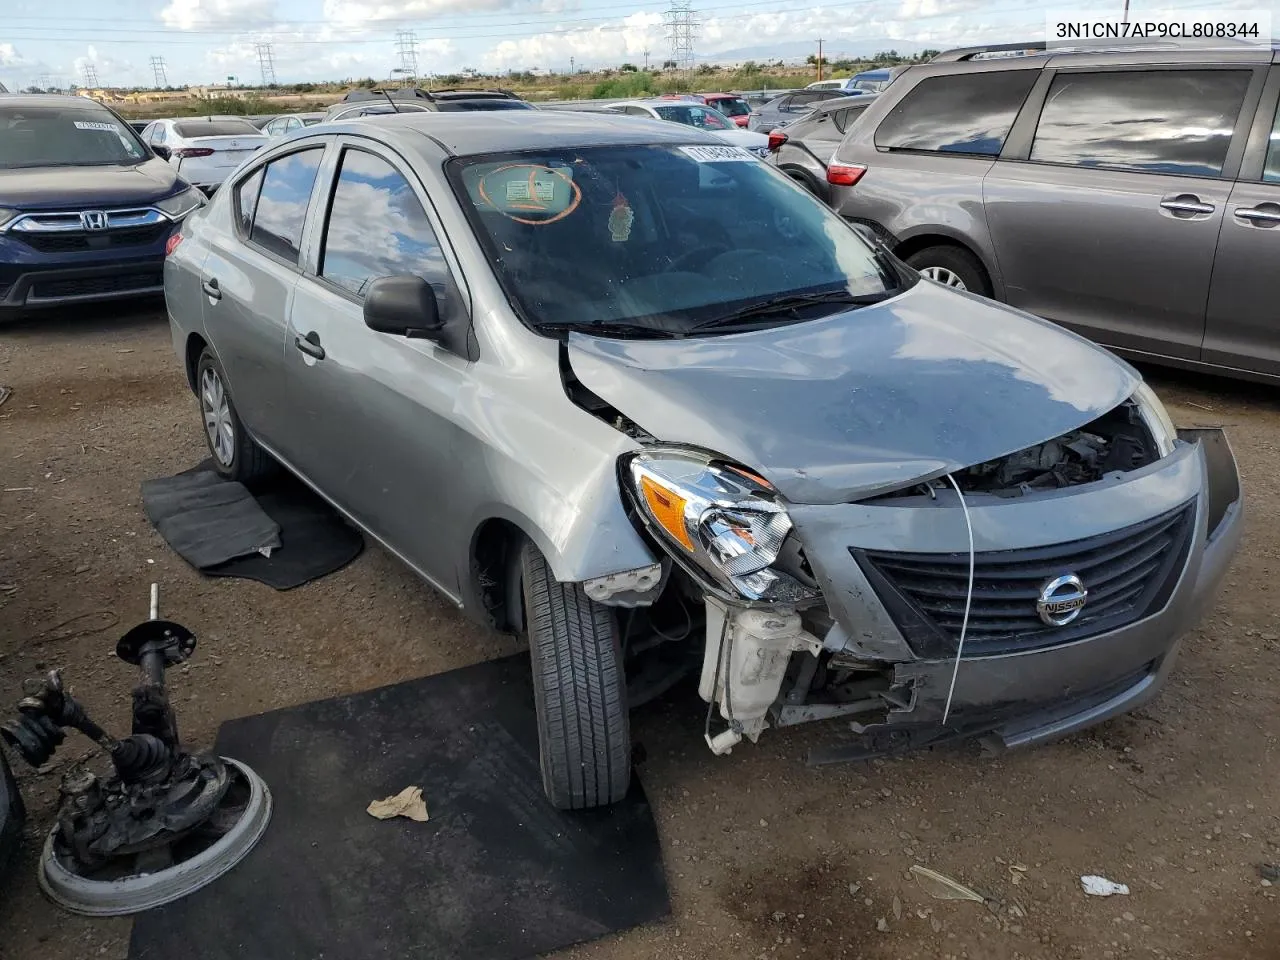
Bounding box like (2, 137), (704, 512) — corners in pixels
(521, 543), (631, 810)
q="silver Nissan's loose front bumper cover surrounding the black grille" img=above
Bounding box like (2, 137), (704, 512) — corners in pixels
(791, 430), (1243, 746)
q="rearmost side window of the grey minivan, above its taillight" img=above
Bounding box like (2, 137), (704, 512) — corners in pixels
(876, 70), (1039, 156)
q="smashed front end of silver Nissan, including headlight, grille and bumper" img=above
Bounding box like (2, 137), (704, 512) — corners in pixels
(596, 387), (1240, 760)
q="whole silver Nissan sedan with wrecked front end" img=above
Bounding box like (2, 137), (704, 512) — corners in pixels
(165, 113), (1242, 808)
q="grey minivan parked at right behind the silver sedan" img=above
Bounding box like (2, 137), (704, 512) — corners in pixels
(828, 42), (1280, 378)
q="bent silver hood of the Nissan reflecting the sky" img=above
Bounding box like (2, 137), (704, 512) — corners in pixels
(568, 282), (1140, 503)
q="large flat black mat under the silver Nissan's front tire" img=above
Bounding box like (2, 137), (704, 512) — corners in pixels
(129, 655), (669, 960)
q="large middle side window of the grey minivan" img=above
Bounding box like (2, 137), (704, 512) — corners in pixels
(1030, 70), (1251, 177)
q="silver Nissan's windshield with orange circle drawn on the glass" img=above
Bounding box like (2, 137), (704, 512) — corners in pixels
(449, 145), (905, 335)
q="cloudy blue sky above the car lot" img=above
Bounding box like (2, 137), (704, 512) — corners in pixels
(0, 0), (1280, 90)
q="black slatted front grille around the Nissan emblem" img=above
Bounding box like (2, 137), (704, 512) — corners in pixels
(852, 503), (1194, 655)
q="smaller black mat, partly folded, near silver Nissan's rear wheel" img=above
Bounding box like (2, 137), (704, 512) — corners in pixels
(142, 460), (365, 590)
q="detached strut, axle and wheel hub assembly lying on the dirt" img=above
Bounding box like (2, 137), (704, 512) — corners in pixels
(0, 584), (271, 916)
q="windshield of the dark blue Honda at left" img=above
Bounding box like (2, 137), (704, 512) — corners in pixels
(0, 104), (151, 169)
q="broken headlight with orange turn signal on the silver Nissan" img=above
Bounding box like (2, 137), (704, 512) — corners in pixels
(628, 449), (817, 602)
